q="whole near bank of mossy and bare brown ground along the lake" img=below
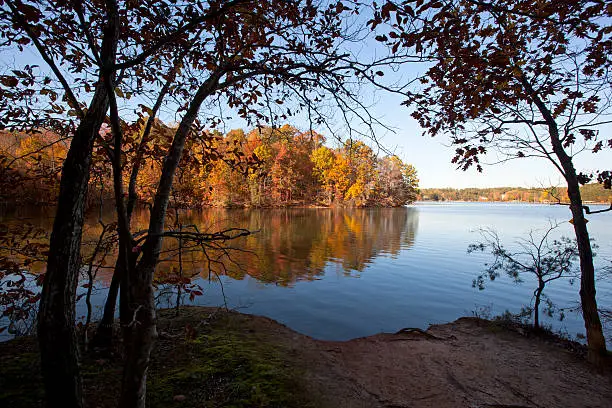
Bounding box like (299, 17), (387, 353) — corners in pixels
(0, 307), (612, 408)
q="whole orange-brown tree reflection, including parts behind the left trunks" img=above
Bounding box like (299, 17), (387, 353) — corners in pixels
(0, 208), (418, 286)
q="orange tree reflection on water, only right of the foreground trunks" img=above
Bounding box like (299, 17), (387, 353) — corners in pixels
(146, 208), (418, 286)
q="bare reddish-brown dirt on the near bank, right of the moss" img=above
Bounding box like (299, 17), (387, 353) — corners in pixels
(296, 318), (612, 408)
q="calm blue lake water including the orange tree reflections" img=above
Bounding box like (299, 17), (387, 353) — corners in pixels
(0, 203), (612, 340)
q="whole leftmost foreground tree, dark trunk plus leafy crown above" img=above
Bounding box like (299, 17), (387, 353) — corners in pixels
(0, 0), (266, 407)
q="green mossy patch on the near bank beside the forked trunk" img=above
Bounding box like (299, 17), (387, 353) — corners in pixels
(148, 332), (313, 407)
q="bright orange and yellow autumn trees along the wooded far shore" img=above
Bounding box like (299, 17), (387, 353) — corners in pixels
(0, 120), (418, 208)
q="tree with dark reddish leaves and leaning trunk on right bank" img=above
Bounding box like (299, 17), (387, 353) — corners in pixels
(370, 0), (612, 361)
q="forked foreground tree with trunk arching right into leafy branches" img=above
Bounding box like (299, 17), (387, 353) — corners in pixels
(109, 1), (424, 407)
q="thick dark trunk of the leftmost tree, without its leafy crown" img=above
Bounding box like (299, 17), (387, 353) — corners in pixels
(38, 86), (108, 408)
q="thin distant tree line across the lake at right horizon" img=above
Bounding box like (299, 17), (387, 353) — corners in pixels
(418, 183), (612, 203)
